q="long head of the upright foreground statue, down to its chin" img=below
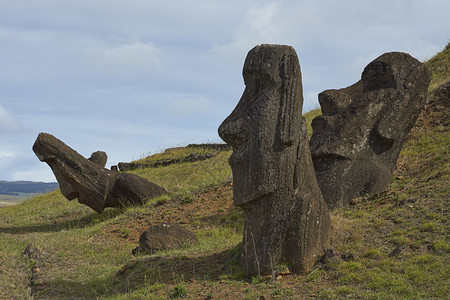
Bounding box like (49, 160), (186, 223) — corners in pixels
(219, 45), (302, 205)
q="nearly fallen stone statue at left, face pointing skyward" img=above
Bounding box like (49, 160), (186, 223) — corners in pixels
(33, 133), (166, 213)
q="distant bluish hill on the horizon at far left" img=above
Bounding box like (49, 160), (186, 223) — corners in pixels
(0, 181), (58, 196)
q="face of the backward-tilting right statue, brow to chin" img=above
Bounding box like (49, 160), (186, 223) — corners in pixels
(311, 57), (402, 159)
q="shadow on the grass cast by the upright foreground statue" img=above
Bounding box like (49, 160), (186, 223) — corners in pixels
(34, 244), (244, 299)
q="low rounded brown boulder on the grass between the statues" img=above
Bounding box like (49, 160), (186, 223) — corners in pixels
(133, 223), (197, 254)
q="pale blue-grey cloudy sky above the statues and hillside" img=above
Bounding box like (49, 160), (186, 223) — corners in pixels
(0, 0), (450, 181)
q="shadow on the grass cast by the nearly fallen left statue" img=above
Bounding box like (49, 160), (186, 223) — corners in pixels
(0, 208), (123, 234)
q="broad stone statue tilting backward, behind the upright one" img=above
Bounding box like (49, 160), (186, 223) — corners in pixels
(310, 52), (430, 209)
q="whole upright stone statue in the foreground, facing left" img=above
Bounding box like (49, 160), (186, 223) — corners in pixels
(219, 45), (330, 276)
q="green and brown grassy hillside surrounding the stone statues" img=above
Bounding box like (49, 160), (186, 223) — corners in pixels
(0, 46), (450, 299)
